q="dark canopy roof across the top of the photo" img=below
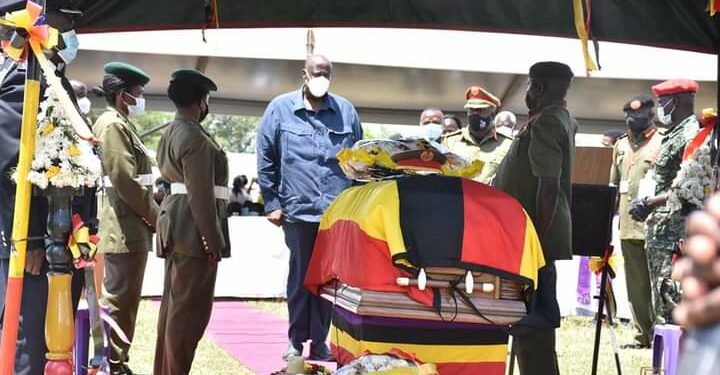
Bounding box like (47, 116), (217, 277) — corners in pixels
(76, 0), (720, 53)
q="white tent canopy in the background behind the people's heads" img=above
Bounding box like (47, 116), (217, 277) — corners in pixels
(69, 28), (716, 133)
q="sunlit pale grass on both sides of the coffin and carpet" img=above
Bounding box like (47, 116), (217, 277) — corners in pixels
(130, 300), (652, 375)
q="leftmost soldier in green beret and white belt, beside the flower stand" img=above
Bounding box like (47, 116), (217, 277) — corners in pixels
(93, 62), (158, 374)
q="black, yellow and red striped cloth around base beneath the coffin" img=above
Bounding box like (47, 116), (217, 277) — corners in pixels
(330, 306), (508, 375)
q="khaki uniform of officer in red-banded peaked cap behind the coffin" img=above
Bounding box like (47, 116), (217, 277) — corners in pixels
(442, 125), (512, 184)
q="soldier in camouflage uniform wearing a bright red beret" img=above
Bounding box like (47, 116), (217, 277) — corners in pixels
(629, 79), (700, 324)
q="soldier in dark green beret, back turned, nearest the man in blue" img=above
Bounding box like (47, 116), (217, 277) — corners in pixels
(153, 69), (230, 375)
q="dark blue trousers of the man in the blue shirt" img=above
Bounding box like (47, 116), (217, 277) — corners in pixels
(283, 222), (332, 346)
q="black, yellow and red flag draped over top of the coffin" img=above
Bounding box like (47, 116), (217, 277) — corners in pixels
(305, 176), (545, 306)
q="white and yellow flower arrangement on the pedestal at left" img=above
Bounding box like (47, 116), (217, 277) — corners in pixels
(14, 86), (102, 189)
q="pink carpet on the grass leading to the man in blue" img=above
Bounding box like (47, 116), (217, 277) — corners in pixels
(207, 301), (335, 375)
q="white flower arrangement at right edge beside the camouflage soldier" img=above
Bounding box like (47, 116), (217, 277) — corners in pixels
(667, 143), (713, 211)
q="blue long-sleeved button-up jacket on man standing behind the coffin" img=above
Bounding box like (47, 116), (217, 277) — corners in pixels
(257, 90), (363, 222)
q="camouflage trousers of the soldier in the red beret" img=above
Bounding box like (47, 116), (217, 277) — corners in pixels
(646, 212), (685, 324)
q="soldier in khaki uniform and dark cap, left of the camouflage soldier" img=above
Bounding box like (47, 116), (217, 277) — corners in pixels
(610, 95), (662, 348)
